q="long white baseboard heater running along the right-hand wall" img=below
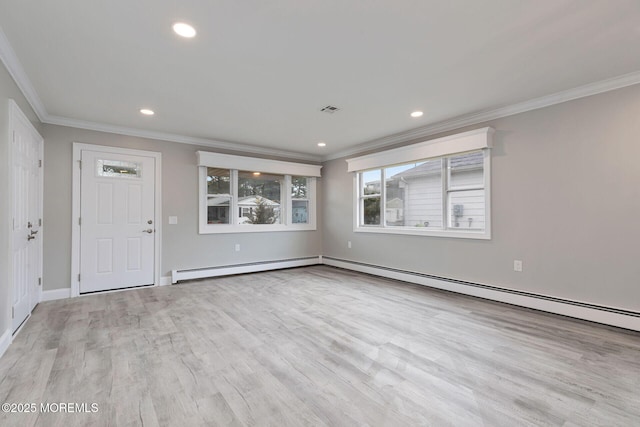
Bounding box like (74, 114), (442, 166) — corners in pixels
(322, 256), (640, 331)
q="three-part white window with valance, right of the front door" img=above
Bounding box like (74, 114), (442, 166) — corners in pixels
(198, 151), (321, 234)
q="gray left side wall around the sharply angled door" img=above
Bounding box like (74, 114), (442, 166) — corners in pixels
(0, 62), (40, 335)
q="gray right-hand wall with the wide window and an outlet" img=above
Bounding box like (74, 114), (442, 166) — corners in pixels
(323, 85), (640, 311)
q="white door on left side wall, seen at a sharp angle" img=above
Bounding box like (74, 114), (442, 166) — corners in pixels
(10, 104), (42, 332)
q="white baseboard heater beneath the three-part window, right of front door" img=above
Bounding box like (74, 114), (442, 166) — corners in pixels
(171, 255), (322, 283)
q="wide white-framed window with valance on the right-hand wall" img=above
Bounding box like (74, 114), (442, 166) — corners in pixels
(347, 128), (493, 239)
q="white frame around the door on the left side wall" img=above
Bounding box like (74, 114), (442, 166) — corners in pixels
(5, 99), (44, 335)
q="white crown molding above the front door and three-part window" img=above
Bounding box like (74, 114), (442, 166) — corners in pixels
(42, 115), (322, 163)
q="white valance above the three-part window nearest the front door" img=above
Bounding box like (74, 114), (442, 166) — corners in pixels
(197, 151), (322, 177)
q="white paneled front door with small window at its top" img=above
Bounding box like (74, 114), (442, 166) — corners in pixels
(79, 150), (156, 294)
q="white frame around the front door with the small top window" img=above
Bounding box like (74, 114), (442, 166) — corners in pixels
(71, 142), (162, 297)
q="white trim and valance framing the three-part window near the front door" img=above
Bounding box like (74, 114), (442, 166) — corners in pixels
(197, 151), (322, 234)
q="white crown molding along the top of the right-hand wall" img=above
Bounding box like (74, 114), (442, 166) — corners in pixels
(322, 71), (640, 161)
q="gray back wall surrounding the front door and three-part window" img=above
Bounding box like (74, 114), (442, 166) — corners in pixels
(42, 125), (322, 290)
